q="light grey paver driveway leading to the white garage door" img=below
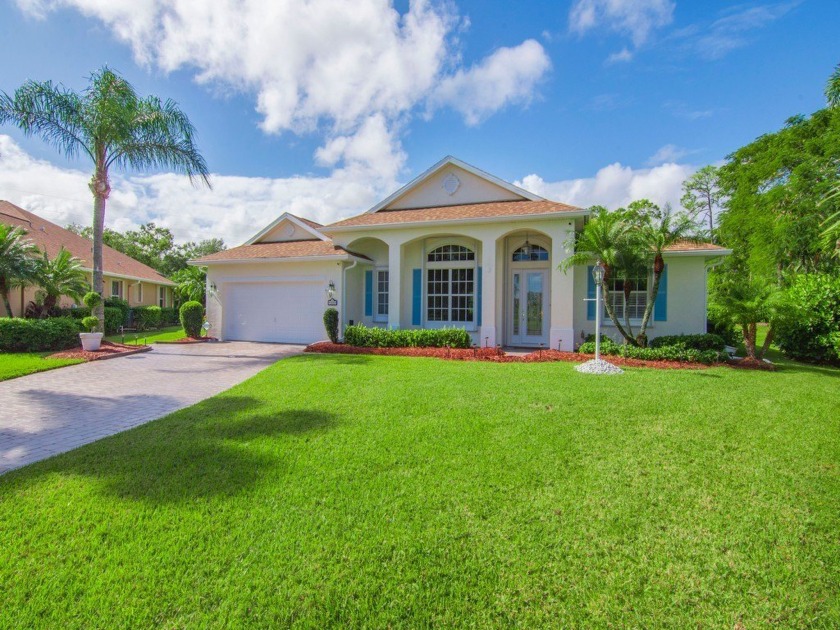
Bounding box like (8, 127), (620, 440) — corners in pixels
(0, 341), (303, 473)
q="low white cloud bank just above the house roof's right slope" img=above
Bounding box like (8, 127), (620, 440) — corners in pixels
(516, 162), (695, 208)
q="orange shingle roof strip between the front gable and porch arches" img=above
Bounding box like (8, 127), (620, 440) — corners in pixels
(326, 199), (584, 231)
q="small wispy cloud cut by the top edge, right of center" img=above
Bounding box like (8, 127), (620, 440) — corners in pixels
(569, 0), (675, 48)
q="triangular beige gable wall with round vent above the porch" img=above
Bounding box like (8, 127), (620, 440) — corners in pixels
(388, 165), (522, 210)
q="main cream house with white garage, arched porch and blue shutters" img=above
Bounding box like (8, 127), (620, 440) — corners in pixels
(192, 157), (729, 350)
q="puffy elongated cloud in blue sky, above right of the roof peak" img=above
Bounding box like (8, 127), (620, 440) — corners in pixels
(429, 39), (551, 125)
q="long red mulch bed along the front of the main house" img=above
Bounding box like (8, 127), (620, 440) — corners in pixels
(305, 341), (720, 370)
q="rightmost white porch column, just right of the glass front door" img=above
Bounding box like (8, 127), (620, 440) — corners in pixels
(549, 221), (575, 352)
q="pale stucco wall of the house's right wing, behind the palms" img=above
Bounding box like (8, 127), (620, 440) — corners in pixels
(574, 255), (706, 344)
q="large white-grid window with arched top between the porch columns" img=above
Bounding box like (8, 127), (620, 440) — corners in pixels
(426, 245), (476, 325)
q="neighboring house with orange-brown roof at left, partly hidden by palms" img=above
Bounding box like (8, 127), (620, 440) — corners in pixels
(0, 201), (175, 317)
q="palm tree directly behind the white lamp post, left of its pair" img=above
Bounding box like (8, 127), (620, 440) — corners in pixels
(560, 206), (639, 346)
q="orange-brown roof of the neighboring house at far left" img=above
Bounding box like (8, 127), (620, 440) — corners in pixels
(0, 200), (175, 286)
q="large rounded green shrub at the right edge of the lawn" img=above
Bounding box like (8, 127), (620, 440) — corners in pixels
(774, 274), (840, 364)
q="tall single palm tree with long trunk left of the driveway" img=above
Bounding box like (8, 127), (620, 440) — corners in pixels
(0, 67), (210, 328)
